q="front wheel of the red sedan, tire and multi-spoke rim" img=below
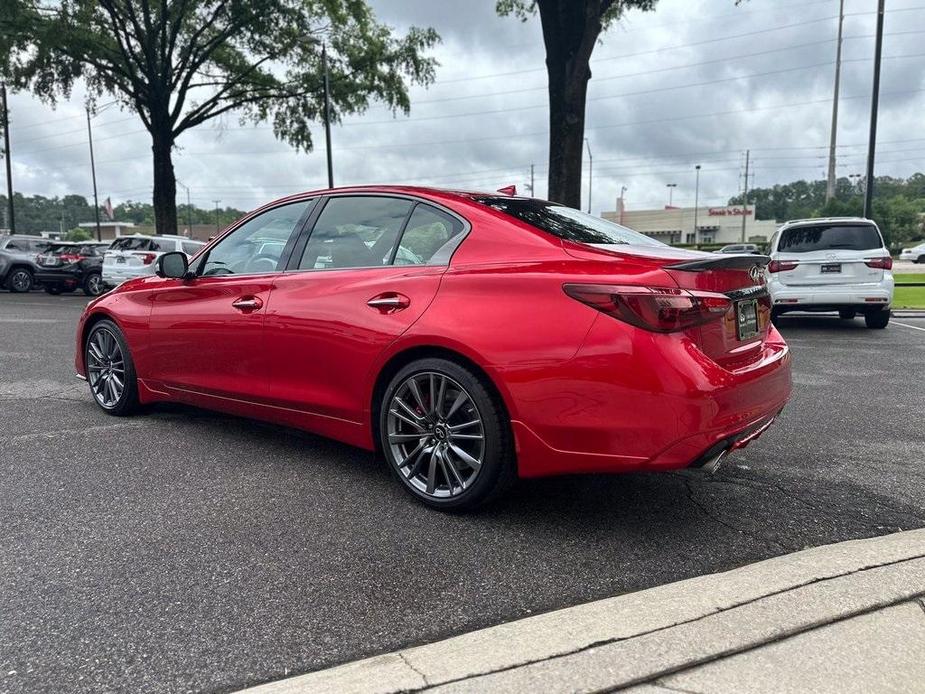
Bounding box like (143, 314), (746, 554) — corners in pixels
(84, 320), (138, 417)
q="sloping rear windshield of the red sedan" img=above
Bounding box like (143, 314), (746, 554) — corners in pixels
(474, 195), (665, 246)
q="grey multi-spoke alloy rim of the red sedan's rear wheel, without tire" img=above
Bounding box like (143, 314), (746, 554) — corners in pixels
(386, 371), (485, 499)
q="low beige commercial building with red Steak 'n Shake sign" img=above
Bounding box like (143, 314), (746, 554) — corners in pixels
(602, 198), (778, 244)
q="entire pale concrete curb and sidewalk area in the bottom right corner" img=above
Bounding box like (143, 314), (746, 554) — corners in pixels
(238, 530), (925, 694)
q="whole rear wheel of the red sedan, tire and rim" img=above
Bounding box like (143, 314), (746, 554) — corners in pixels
(379, 359), (516, 510)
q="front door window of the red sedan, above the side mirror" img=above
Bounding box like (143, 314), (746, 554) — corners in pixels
(197, 200), (313, 276)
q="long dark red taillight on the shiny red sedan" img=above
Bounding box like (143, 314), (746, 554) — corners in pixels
(562, 284), (732, 333)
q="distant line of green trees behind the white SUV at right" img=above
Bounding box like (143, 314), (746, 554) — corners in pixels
(729, 173), (925, 247)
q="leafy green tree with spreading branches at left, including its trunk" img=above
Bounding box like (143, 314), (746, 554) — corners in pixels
(0, 0), (439, 233)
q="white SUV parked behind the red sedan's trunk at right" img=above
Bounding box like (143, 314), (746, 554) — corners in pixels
(767, 217), (893, 328)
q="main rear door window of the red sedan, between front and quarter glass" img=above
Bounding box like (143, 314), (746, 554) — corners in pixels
(299, 195), (414, 270)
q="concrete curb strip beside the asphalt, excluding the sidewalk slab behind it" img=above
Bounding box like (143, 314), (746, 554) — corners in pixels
(236, 530), (925, 694)
